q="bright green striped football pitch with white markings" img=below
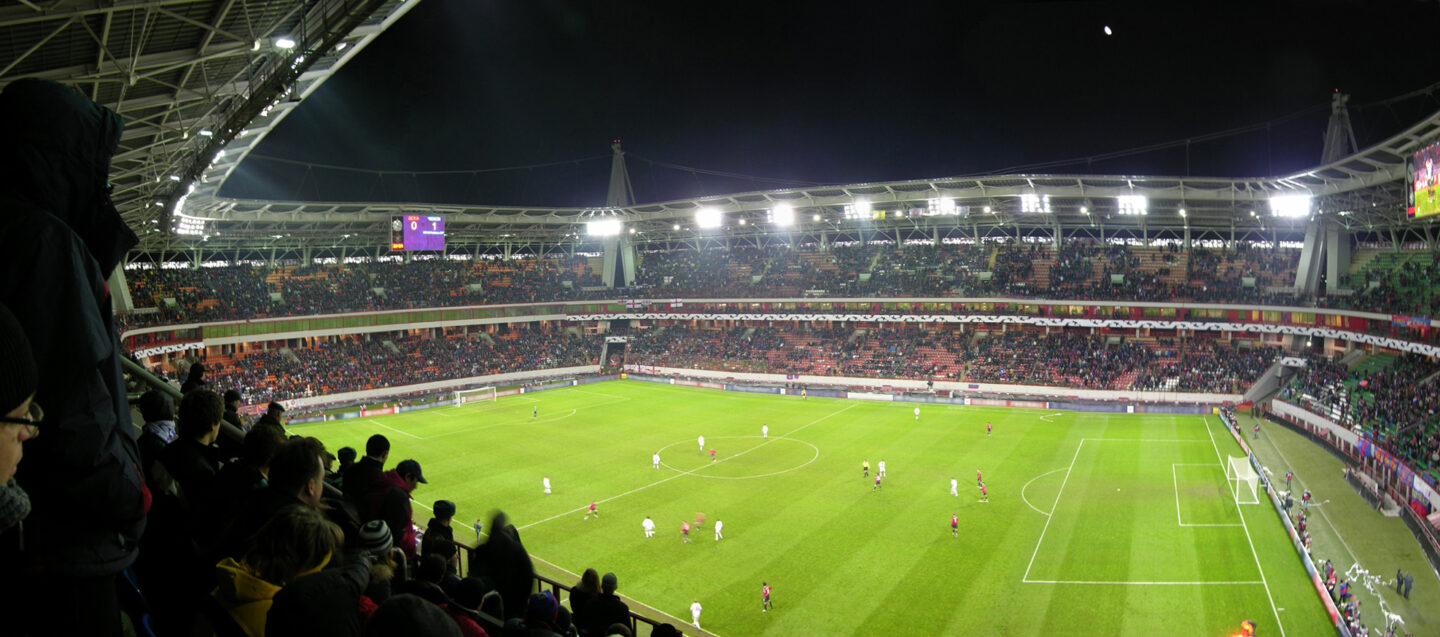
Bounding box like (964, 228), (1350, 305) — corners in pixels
(292, 380), (1333, 636)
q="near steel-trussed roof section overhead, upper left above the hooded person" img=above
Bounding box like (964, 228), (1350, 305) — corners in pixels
(0, 0), (418, 245)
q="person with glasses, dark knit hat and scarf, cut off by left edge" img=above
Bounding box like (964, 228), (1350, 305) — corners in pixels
(0, 306), (43, 538)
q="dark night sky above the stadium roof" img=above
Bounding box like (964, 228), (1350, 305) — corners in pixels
(223, 0), (1440, 206)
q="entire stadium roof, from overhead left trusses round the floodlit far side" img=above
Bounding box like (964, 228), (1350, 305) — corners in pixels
(0, 0), (1440, 252)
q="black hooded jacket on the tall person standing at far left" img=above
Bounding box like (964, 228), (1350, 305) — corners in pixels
(0, 79), (145, 576)
